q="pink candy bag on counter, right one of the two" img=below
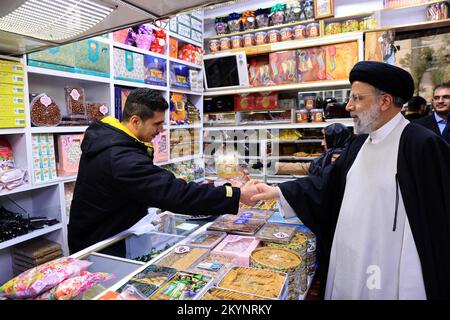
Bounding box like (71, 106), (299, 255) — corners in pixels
(35, 271), (115, 300)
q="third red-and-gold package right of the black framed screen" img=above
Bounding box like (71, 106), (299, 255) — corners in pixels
(297, 47), (326, 82)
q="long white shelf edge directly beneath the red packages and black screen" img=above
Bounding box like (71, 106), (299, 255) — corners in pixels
(203, 80), (350, 97)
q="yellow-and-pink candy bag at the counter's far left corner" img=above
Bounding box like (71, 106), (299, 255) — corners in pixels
(0, 257), (92, 299)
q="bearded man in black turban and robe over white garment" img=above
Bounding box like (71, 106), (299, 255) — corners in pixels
(252, 61), (450, 299)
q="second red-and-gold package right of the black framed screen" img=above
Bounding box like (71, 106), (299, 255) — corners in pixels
(269, 50), (297, 84)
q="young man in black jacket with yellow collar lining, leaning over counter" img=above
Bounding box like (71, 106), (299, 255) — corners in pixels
(68, 88), (256, 253)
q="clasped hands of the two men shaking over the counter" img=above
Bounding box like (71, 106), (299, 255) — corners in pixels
(231, 180), (280, 206)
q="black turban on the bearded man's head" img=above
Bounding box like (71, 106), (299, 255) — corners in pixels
(350, 61), (414, 102)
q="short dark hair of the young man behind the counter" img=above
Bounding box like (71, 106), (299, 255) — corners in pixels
(122, 88), (169, 122)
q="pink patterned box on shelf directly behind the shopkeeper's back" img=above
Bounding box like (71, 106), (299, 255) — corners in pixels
(56, 134), (84, 176)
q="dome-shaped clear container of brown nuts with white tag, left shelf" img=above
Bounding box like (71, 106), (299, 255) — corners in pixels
(30, 93), (62, 127)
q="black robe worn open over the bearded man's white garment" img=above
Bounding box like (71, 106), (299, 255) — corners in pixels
(279, 123), (450, 299)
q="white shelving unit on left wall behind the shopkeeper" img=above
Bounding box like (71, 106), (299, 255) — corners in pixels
(0, 10), (204, 284)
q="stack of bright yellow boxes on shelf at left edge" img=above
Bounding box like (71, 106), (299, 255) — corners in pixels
(0, 60), (25, 128)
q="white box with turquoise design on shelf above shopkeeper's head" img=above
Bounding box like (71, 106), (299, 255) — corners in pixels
(114, 48), (145, 82)
